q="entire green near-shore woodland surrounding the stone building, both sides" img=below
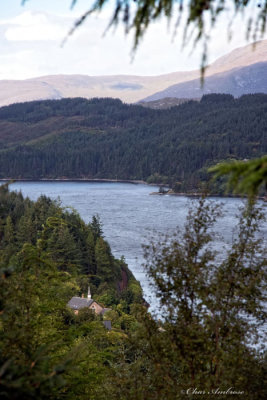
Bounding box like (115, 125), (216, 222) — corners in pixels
(0, 185), (267, 400)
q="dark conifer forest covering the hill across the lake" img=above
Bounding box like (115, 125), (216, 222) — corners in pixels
(0, 94), (267, 192)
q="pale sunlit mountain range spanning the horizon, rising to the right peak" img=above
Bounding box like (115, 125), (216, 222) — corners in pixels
(0, 40), (267, 106)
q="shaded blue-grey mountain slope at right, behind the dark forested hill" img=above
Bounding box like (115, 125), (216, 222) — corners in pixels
(143, 62), (267, 103)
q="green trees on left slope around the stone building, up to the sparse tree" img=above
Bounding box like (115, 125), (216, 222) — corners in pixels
(0, 185), (144, 400)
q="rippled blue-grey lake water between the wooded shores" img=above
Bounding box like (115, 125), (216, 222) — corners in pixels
(5, 182), (267, 304)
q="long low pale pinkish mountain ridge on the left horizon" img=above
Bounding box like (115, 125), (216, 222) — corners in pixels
(0, 72), (197, 107)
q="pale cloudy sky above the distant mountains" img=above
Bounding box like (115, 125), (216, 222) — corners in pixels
(0, 0), (266, 79)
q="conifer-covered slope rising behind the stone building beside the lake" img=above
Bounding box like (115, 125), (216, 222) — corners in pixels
(0, 185), (143, 306)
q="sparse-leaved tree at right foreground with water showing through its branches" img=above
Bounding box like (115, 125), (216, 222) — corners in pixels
(142, 199), (267, 399)
